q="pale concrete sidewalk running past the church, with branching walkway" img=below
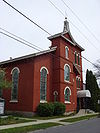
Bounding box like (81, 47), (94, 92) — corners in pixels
(0, 113), (96, 130)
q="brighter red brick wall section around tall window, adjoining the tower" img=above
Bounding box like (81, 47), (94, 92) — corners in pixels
(33, 54), (53, 111)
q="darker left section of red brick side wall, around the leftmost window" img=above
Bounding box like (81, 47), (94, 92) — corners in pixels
(3, 60), (34, 111)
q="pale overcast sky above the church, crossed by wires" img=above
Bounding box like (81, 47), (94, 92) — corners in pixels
(0, 0), (100, 81)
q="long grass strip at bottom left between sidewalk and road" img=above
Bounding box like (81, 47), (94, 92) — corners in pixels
(0, 122), (61, 133)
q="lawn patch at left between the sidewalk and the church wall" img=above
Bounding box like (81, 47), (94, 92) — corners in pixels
(0, 116), (36, 126)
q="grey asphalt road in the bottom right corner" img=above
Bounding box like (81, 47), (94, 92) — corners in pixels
(29, 118), (100, 133)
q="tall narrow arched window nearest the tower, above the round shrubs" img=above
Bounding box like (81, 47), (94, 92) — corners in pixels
(40, 67), (48, 101)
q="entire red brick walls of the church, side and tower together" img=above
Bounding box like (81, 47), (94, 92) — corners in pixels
(3, 31), (82, 112)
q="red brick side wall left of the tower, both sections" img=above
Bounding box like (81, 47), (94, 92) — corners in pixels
(3, 54), (53, 112)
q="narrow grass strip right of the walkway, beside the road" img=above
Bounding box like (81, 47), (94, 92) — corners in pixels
(61, 114), (98, 123)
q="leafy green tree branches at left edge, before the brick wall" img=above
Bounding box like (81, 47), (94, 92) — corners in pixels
(0, 68), (11, 96)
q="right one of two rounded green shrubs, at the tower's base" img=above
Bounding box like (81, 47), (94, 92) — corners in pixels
(53, 102), (66, 115)
